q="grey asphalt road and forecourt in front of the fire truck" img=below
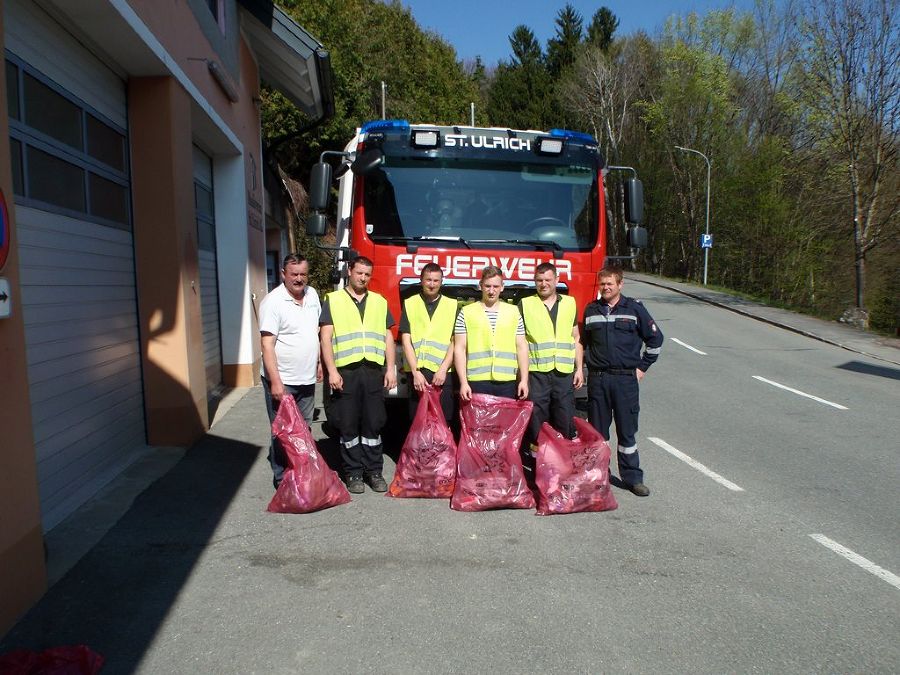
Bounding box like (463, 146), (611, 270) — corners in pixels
(0, 281), (900, 673)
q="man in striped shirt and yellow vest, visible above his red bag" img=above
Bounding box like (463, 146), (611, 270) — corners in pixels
(453, 265), (528, 401)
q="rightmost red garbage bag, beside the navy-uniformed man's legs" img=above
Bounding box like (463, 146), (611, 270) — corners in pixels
(534, 417), (619, 516)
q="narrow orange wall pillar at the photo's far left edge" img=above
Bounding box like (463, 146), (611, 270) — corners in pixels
(0, 3), (47, 635)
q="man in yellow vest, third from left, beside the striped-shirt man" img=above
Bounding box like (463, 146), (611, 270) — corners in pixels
(398, 262), (457, 423)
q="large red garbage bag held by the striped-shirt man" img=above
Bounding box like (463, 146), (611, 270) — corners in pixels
(450, 394), (534, 511)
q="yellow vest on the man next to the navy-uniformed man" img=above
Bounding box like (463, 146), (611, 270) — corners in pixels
(521, 295), (577, 373)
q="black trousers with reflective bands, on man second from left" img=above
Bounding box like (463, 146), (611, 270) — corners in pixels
(329, 361), (387, 478)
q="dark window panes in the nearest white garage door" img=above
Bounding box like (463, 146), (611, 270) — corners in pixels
(6, 57), (131, 229)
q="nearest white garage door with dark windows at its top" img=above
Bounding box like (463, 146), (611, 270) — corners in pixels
(4, 0), (146, 530)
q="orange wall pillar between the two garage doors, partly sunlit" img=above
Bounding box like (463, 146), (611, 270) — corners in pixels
(128, 77), (209, 446)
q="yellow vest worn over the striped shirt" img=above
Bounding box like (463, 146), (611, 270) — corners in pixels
(462, 301), (519, 382)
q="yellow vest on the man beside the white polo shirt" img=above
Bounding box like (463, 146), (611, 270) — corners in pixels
(328, 289), (387, 368)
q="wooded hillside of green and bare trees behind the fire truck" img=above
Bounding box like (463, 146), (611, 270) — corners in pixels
(262, 0), (900, 334)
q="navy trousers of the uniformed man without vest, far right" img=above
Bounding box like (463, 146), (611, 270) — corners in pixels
(588, 370), (644, 485)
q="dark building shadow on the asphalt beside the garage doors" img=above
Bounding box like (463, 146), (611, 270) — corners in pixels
(0, 435), (261, 672)
